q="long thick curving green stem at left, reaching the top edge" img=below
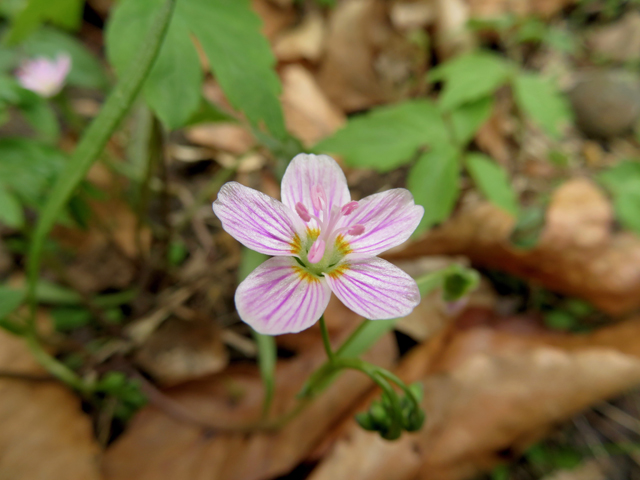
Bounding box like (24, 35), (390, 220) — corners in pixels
(26, 0), (175, 391)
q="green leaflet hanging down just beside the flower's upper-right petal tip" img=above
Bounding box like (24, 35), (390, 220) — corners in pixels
(407, 144), (460, 234)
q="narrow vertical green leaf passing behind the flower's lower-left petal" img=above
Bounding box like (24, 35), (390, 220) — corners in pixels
(238, 247), (277, 417)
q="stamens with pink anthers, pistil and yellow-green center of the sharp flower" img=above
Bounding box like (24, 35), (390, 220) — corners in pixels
(295, 185), (365, 273)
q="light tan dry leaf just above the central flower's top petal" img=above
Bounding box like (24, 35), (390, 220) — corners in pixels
(282, 65), (346, 147)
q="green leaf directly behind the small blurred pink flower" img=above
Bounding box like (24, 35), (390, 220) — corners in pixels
(20, 27), (108, 89)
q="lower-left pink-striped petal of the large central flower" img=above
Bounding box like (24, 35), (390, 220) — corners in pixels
(235, 257), (331, 335)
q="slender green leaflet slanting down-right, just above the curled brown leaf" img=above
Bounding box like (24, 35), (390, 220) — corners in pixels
(465, 153), (519, 217)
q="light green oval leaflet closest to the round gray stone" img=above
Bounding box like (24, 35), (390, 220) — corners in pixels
(513, 72), (571, 139)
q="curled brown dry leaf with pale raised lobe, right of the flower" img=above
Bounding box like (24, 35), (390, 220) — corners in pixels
(388, 179), (640, 314)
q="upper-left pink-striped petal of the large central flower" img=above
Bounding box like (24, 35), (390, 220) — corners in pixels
(213, 182), (305, 256)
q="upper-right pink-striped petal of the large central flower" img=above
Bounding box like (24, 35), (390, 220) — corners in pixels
(340, 188), (424, 256)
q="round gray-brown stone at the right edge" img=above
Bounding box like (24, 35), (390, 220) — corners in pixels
(569, 71), (640, 139)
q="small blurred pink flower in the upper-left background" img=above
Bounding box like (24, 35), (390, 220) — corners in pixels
(16, 53), (71, 98)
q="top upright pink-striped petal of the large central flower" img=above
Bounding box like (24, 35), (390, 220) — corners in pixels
(281, 153), (351, 227)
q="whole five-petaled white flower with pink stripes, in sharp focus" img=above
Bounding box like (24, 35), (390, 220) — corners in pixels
(213, 154), (424, 335)
